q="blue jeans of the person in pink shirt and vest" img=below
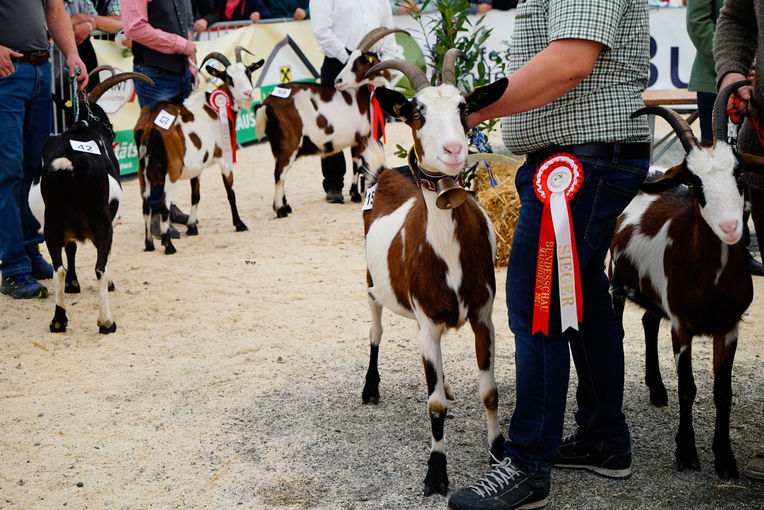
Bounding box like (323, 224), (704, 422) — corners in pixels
(133, 64), (194, 213)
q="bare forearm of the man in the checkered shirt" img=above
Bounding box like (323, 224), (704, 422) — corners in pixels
(467, 39), (603, 127)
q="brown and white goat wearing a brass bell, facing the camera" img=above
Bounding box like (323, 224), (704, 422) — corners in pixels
(362, 50), (506, 495)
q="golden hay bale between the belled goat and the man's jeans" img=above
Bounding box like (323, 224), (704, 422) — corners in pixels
(472, 156), (523, 267)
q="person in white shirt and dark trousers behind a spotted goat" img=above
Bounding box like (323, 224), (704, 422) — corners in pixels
(310, 0), (395, 204)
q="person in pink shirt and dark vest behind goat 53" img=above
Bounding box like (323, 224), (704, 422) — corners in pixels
(120, 0), (196, 238)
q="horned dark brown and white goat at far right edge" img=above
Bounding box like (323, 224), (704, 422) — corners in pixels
(610, 83), (764, 478)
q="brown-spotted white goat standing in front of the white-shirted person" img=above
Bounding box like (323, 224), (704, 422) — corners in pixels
(255, 27), (408, 218)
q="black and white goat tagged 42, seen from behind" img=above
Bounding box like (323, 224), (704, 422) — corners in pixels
(29, 71), (154, 334)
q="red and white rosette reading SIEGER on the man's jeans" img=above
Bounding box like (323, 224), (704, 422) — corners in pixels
(531, 153), (583, 335)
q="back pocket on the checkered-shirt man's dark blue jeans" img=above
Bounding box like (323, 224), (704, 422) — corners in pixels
(584, 179), (641, 250)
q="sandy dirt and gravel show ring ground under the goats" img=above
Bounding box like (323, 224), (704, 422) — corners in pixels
(0, 124), (764, 509)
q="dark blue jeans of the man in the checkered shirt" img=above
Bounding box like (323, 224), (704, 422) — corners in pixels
(505, 147), (648, 478)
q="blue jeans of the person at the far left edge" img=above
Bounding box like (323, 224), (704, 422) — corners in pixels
(0, 62), (52, 276)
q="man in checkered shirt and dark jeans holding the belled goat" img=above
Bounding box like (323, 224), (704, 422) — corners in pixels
(449, 0), (651, 510)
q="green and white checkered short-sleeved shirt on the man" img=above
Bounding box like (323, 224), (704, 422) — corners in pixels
(501, 0), (651, 154)
